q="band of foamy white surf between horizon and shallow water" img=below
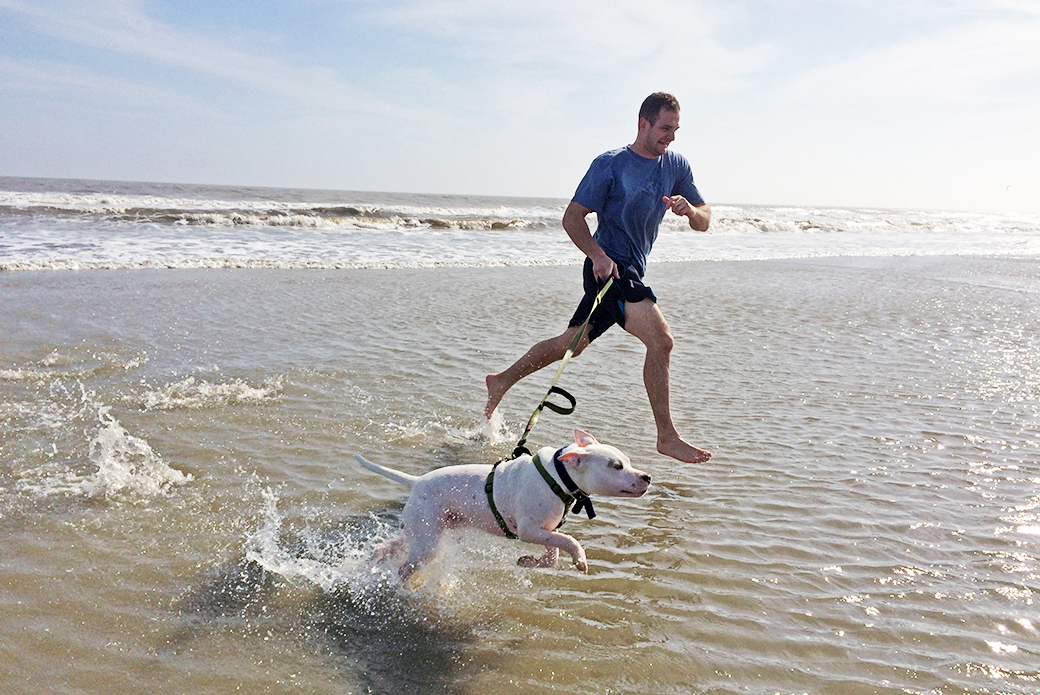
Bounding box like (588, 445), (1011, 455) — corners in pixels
(0, 179), (1040, 271)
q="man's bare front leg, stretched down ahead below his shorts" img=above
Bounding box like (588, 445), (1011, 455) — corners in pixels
(625, 300), (711, 463)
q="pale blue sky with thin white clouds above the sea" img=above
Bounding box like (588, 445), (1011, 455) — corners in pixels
(0, 0), (1040, 212)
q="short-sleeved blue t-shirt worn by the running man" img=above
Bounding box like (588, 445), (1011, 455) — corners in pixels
(574, 147), (704, 278)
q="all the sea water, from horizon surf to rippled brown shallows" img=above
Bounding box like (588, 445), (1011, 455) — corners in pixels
(0, 177), (1040, 695)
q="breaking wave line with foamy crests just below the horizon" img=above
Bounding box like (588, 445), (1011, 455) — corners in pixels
(6, 191), (1040, 235)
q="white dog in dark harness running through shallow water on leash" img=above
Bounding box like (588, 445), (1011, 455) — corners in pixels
(357, 430), (650, 580)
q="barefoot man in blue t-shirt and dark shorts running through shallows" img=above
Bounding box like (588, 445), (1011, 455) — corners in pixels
(485, 93), (711, 463)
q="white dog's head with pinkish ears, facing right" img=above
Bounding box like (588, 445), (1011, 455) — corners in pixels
(560, 430), (650, 497)
